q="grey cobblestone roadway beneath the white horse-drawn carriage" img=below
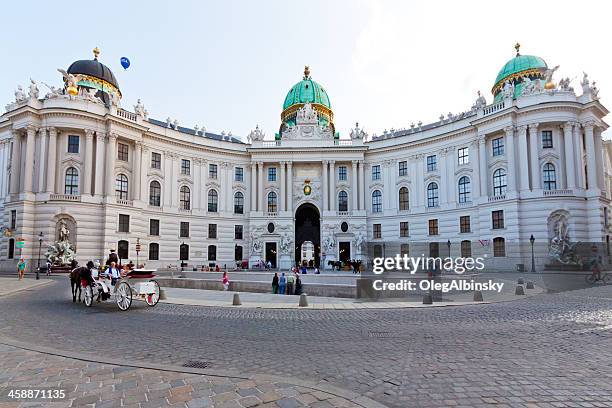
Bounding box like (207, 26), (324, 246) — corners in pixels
(0, 278), (612, 408)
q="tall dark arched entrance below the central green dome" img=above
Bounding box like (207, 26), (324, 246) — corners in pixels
(295, 203), (321, 267)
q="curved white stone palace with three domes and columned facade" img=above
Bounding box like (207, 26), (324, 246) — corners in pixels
(0, 50), (612, 269)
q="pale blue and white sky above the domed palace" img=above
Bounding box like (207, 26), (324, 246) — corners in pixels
(0, 0), (612, 139)
